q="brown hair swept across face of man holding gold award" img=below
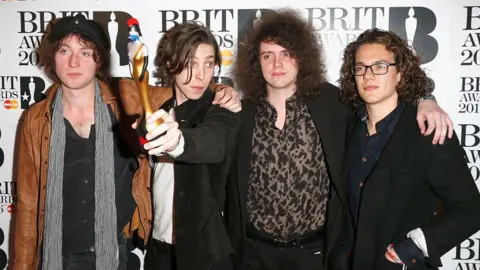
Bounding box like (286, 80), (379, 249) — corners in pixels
(154, 22), (222, 87)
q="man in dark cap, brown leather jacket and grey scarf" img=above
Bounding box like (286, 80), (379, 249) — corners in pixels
(13, 15), (237, 270)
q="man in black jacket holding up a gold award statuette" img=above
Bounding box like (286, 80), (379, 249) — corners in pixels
(120, 20), (240, 270)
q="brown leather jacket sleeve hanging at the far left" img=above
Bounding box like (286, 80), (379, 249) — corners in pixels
(13, 110), (40, 270)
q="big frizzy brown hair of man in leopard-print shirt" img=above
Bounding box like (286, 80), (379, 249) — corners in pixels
(232, 9), (326, 102)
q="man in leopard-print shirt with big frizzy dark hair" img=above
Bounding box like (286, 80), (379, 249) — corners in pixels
(227, 7), (451, 270)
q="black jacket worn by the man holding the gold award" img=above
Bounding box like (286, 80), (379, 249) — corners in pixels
(173, 90), (244, 270)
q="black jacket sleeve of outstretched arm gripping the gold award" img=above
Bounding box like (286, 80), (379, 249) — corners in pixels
(175, 105), (240, 163)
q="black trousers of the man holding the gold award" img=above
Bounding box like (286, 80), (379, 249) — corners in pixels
(143, 237), (233, 270)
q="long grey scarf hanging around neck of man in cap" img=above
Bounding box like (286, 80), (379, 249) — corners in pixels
(42, 81), (118, 270)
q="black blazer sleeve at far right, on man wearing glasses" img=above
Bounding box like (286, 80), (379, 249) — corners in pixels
(420, 134), (480, 267)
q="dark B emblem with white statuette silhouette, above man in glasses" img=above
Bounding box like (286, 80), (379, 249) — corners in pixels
(388, 7), (438, 64)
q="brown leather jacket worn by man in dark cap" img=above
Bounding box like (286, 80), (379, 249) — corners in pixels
(13, 82), (159, 270)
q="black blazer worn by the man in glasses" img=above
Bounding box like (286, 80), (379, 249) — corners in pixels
(344, 104), (480, 270)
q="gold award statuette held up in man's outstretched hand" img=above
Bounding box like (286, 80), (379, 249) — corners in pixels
(132, 44), (164, 146)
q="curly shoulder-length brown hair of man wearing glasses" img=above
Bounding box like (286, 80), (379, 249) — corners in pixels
(338, 28), (433, 110)
